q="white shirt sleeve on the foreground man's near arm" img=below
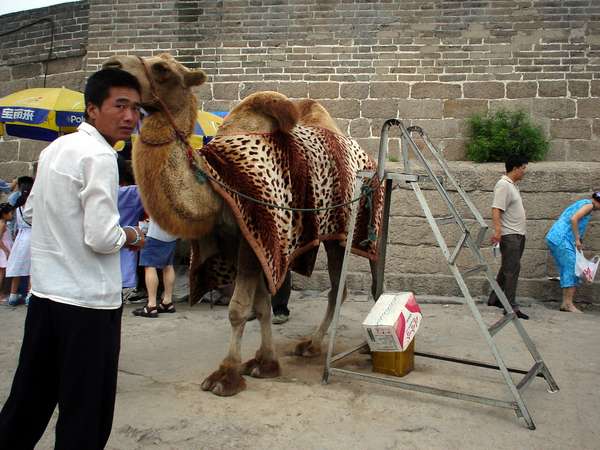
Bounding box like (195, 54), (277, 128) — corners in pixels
(80, 153), (125, 254)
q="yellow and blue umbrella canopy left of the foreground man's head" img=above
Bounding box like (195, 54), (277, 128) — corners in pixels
(0, 88), (85, 141)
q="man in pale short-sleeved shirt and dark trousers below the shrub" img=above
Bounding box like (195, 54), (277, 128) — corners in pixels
(488, 155), (529, 320)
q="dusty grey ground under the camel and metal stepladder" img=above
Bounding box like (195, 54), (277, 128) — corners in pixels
(0, 291), (600, 450)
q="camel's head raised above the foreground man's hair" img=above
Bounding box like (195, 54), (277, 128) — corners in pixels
(102, 53), (206, 114)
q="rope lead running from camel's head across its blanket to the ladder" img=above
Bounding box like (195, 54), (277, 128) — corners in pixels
(137, 56), (377, 241)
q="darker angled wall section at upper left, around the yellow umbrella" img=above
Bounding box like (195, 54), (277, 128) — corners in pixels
(0, 2), (89, 180)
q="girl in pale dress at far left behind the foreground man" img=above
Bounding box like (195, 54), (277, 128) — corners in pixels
(6, 184), (33, 306)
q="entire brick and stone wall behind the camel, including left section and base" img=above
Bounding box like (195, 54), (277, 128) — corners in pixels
(0, 0), (600, 300)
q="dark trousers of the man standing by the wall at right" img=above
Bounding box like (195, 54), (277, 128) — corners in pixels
(488, 234), (525, 309)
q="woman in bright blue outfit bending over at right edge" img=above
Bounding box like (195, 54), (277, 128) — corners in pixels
(546, 191), (600, 313)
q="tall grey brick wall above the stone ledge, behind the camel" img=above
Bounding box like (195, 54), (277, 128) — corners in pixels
(88, 0), (600, 161)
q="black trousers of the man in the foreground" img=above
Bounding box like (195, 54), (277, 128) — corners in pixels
(0, 296), (122, 450)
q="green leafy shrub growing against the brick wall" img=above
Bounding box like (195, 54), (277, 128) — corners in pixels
(467, 110), (550, 162)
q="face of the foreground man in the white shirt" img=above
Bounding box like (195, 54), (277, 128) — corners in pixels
(87, 87), (140, 145)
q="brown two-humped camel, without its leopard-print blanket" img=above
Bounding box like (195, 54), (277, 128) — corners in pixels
(103, 54), (375, 396)
